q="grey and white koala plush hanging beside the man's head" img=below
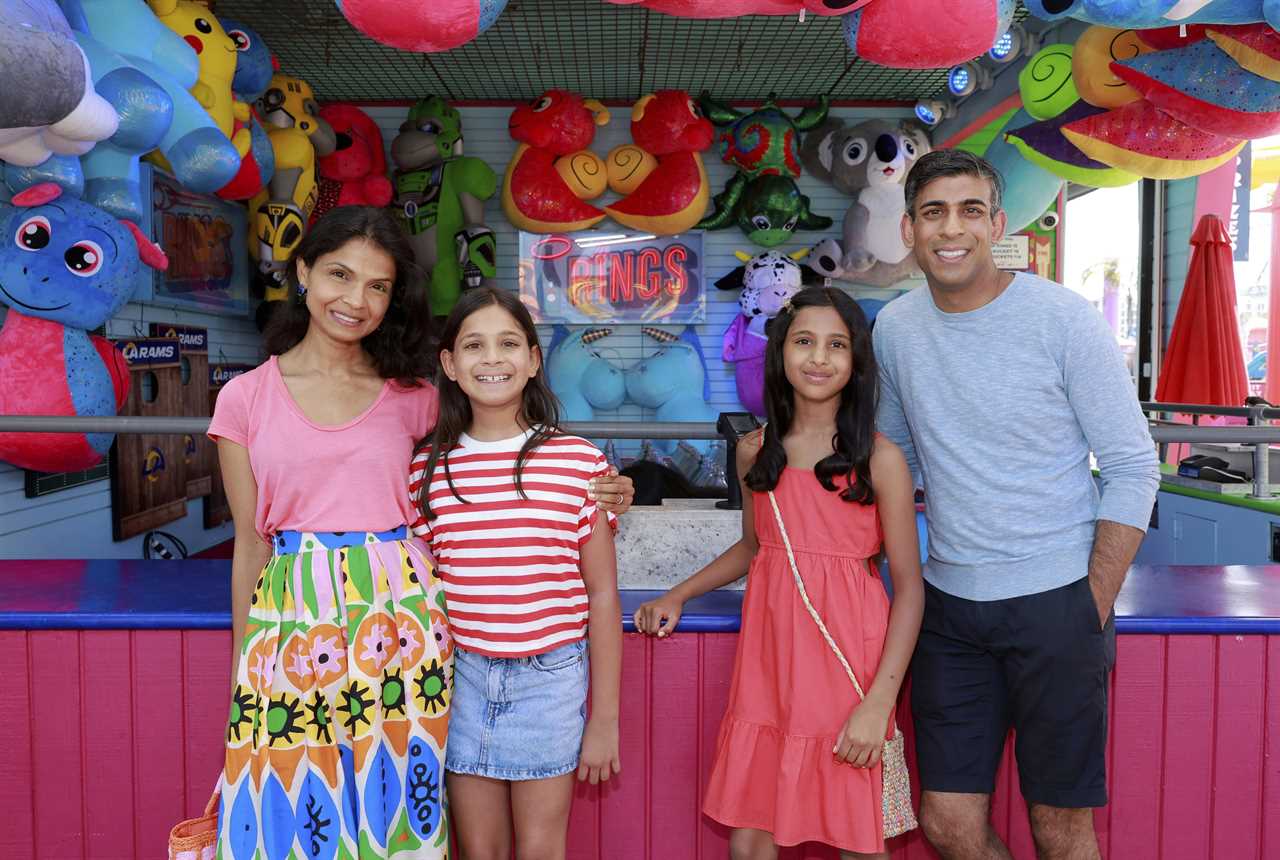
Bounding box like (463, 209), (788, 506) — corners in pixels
(800, 119), (931, 282)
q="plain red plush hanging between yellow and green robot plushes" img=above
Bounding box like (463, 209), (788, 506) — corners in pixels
(311, 104), (396, 223)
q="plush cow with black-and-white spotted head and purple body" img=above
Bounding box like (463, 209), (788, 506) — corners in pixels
(716, 251), (823, 416)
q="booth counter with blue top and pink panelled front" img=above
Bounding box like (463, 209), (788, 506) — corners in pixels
(0, 561), (1280, 860)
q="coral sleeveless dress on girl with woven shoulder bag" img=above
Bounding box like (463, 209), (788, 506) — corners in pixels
(703, 466), (892, 852)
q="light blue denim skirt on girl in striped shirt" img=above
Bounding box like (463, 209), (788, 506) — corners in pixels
(444, 639), (589, 781)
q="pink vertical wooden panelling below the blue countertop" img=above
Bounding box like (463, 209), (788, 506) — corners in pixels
(0, 631), (1280, 860)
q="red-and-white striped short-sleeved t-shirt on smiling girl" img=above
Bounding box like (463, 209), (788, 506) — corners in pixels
(410, 434), (616, 657)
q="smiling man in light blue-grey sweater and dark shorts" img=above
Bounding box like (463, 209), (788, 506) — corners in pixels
(874, 150), (1158, 860)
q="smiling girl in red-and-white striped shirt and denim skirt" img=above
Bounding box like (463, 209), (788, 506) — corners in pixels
(410, 289), (622, 860)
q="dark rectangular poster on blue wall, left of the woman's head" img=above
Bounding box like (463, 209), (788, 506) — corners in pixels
(151, 170), (250, 316)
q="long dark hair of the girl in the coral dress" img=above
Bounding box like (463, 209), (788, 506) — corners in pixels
(745, 287), (879, 504)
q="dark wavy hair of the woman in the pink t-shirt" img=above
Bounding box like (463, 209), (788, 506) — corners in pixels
(262, 206), (435, 386)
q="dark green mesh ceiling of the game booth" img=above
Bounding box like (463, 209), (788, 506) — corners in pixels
(214, 0), (1027, 101)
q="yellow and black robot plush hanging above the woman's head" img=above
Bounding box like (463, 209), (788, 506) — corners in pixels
(248, 74), (337, 323)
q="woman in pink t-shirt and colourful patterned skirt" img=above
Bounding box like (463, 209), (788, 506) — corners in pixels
(209, 206), (632, 857)
